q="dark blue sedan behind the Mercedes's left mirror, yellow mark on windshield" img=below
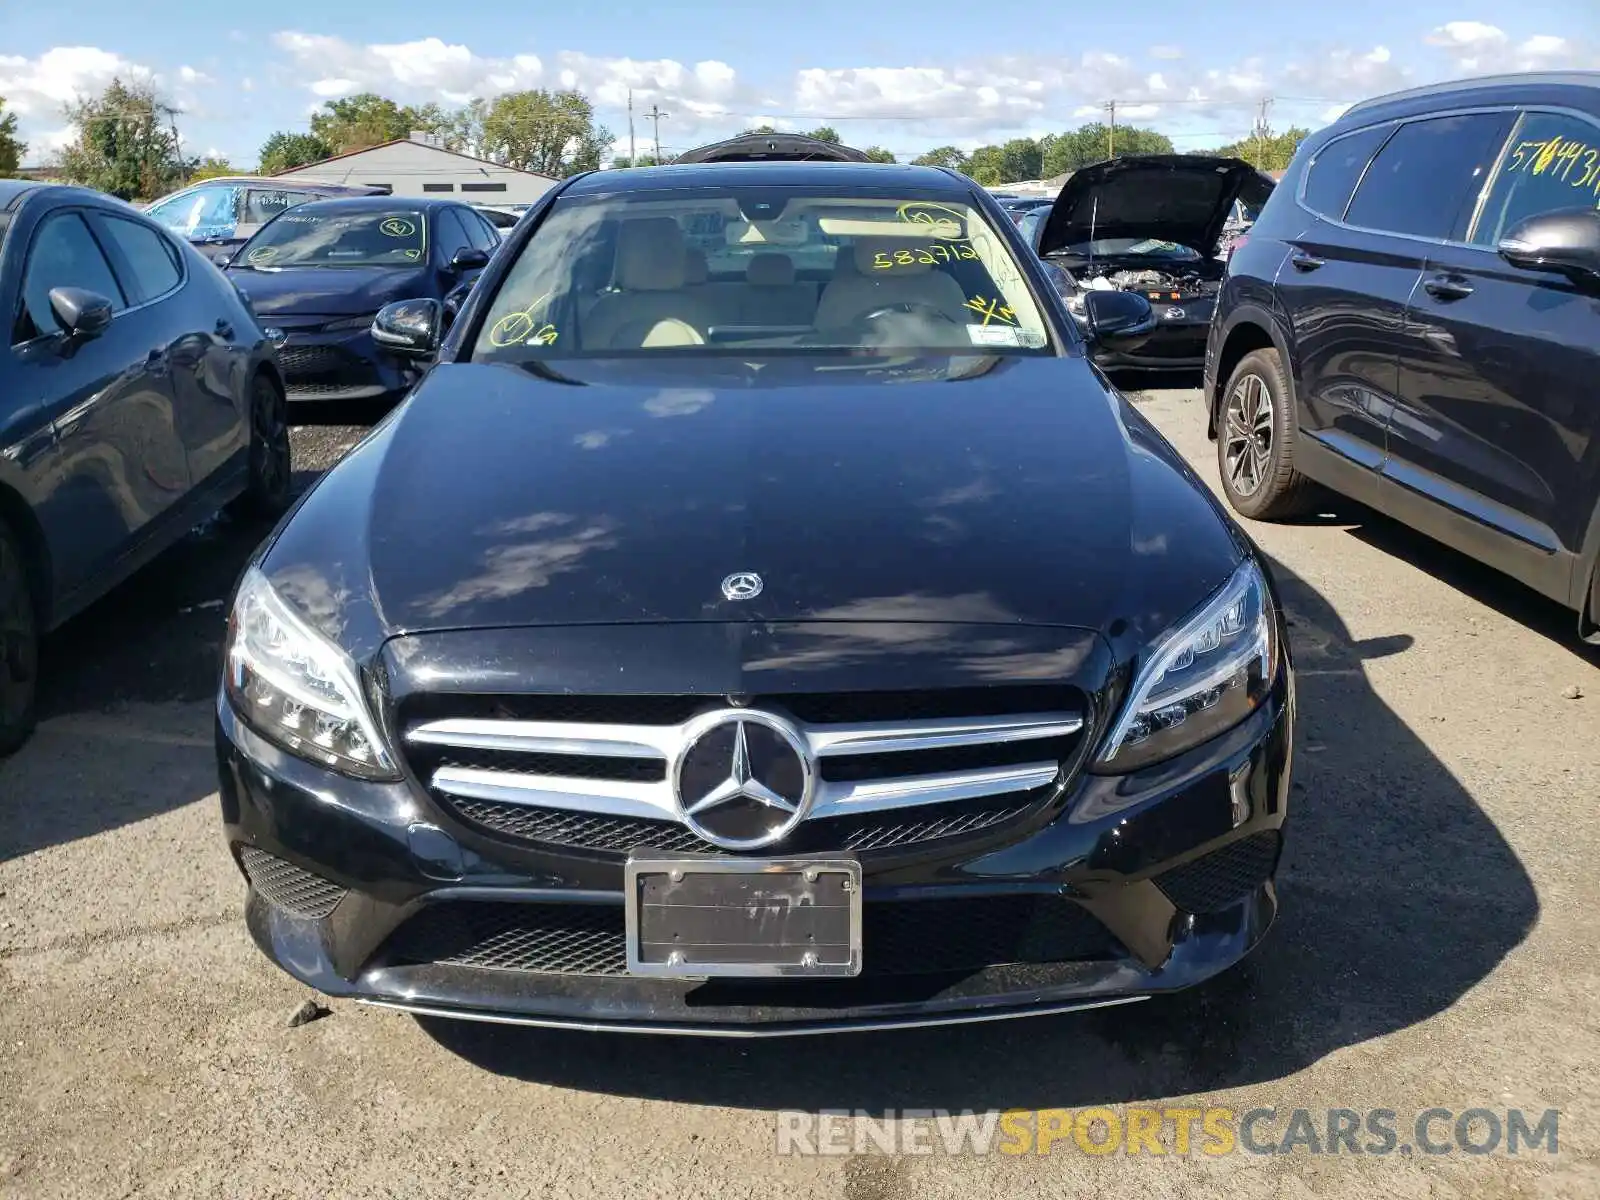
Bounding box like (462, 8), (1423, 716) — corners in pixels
(222, 197), (501, 402)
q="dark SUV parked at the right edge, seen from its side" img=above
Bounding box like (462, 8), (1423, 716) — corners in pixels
(1205, 72), (1600, 640)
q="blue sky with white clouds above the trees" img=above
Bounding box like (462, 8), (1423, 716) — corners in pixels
(0, 0), (1600, 170)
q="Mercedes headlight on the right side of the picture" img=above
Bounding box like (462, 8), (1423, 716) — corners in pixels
(1098, 558), (1278, 771)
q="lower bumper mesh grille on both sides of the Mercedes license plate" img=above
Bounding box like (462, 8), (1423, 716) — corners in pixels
(389, 896), (1114, 976)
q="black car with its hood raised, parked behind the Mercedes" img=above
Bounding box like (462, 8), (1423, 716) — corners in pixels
(1037, 154), (1274, 373)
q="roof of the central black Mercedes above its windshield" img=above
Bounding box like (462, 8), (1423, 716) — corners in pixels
(562, 160), (976, 197)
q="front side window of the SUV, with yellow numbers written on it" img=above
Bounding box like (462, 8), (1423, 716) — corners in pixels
(1472, 112), (1600, 246)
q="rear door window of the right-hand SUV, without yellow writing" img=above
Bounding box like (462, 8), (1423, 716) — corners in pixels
(1346, 114), (1510, 238)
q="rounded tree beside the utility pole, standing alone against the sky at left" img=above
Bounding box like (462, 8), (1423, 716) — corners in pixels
(61, 78), (184, 200)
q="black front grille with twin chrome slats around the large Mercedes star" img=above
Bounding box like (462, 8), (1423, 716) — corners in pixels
(402, 688), (1085, 853)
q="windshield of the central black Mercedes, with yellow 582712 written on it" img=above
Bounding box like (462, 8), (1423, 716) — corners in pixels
(470, 187), (1050, 362)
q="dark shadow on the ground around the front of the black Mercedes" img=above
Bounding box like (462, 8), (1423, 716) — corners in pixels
(419, 553), (1539, 1112)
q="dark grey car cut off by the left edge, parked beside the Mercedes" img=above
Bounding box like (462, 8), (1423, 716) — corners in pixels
(0, 179), (290, 754)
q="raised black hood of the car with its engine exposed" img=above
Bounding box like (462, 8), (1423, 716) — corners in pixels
(1038, 154), (1274, 256)
